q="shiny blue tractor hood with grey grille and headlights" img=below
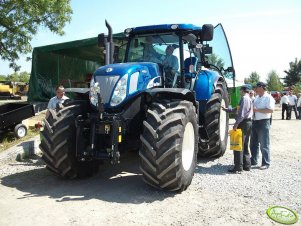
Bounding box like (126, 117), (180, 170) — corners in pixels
(90, 62), (161, 108)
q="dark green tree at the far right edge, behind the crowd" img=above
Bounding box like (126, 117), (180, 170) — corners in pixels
(284, 58), (301, 86)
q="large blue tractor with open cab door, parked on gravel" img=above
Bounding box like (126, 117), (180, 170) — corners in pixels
(40, 22), (235, 191)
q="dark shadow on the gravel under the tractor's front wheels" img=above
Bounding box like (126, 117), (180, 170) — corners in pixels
(1, 153), (177, 204)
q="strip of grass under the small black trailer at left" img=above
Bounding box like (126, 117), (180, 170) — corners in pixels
(0, 128), (40, 152)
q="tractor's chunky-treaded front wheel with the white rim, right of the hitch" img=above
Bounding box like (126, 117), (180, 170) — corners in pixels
(139, 100), (198, 191)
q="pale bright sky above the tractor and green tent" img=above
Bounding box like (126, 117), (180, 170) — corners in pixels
(0, 0), (301, 81)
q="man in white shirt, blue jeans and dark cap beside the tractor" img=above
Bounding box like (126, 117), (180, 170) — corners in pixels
(250, 82), (275, 170)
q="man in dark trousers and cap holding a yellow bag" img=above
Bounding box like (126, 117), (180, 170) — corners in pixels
(222, 86), (253, 173)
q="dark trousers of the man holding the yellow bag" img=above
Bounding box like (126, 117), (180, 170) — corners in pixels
(233, 119), (252, 170)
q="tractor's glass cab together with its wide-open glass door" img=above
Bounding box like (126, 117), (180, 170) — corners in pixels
(120, 24), (235, 89)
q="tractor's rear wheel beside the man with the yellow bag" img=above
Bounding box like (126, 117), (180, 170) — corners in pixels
(198, 81), (229, 158)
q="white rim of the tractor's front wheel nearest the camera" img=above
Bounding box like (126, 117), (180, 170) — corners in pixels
(182, 122), (195, 171)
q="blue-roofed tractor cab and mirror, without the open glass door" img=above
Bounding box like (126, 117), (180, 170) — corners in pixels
(125, 24), (213, 88)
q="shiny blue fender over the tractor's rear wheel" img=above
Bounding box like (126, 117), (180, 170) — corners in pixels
(195, 70), (222, 101)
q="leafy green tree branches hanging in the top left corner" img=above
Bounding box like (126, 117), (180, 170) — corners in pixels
(0, 0), (72, 71)
